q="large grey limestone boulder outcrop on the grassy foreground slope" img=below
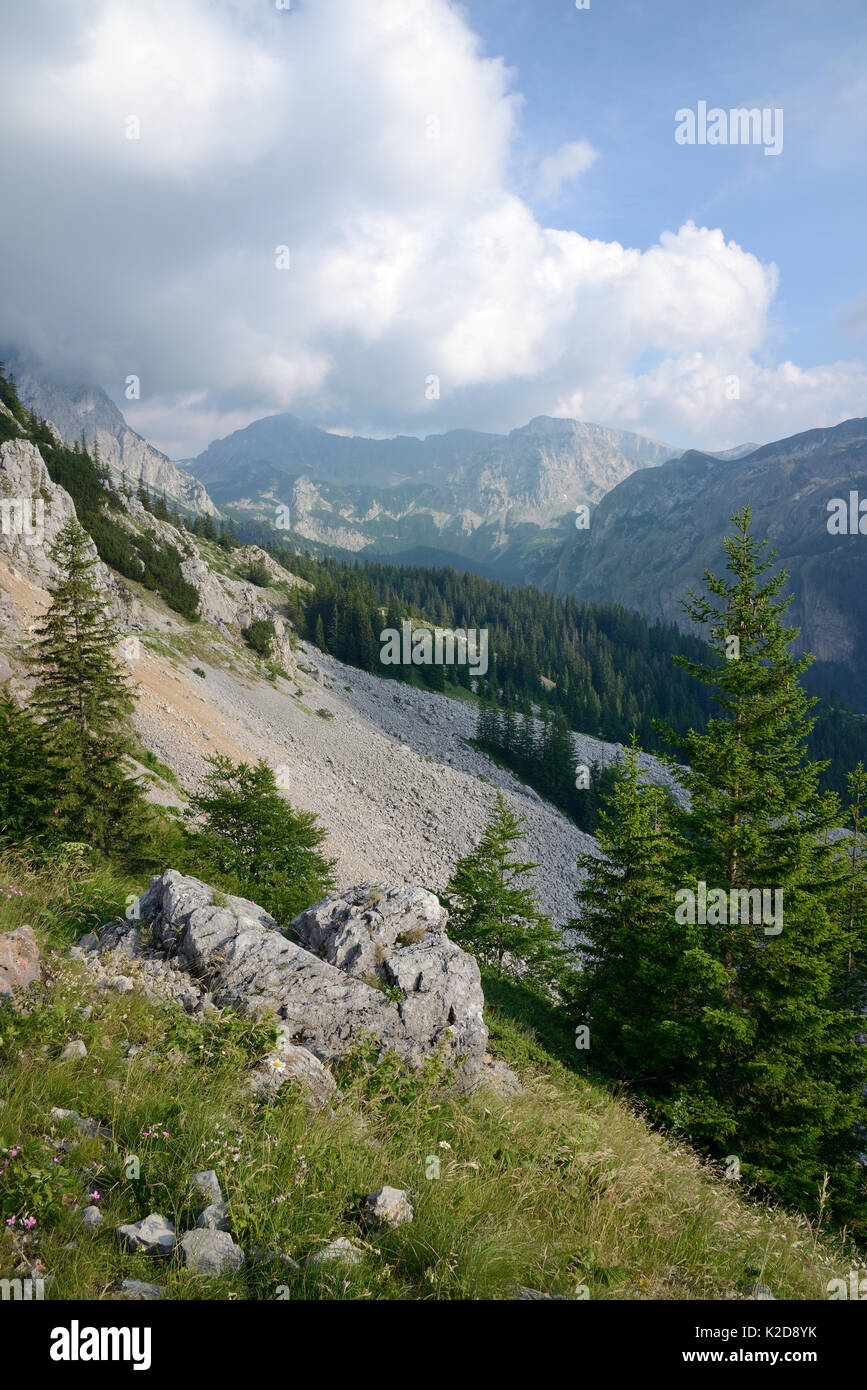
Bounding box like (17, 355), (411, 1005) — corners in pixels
(101, 870), (488, 1104)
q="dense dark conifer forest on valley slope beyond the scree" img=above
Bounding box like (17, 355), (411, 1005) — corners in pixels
(268, 541), (867, 806)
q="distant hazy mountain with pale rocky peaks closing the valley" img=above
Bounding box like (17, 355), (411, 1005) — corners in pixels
(190, 414), (677, 578)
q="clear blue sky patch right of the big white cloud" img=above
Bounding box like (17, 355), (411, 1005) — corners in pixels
(467, 0), (867, 364)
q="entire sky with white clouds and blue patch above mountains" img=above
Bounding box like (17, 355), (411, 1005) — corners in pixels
(0, 0), (867, 459)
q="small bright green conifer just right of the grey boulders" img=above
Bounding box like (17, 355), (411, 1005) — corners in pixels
(443, 791), (564, 984)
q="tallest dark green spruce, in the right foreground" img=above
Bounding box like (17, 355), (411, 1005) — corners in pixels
(672, 507), (867, 1212)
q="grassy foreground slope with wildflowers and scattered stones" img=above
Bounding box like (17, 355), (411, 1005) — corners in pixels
(0, 860), (859, 1300)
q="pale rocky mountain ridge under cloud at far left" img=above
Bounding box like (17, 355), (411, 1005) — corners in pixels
(0, 349), (217, 516)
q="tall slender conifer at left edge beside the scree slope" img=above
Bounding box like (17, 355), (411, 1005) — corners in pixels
(28, 518), (145, 853)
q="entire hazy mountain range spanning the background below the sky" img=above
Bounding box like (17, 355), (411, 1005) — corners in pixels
(4, 350), (867, 710)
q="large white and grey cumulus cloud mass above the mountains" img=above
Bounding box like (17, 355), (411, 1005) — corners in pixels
(0, 0), (866, 457)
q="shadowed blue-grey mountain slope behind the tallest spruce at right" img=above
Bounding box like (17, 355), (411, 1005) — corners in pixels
(546, 418), (867, 708)
